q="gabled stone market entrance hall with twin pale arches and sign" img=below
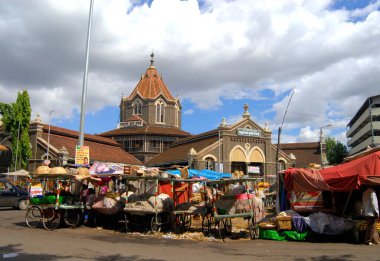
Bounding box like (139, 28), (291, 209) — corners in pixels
(146, 105), (292, 181)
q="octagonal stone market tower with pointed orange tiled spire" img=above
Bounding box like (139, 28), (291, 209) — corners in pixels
(99, 53), (190, 162)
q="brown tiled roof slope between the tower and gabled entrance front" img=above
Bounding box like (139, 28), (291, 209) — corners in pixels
(146, 136), (218, 166)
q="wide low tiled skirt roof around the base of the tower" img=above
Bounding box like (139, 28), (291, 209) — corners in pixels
(99, 125), (191, 137)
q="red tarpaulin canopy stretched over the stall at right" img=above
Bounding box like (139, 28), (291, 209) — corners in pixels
(284, 151), (380, 192)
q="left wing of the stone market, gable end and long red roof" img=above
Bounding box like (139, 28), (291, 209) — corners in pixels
(0, 116), (141, 172)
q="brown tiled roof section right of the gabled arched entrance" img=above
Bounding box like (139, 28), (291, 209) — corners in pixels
(280, 142), (321, 167)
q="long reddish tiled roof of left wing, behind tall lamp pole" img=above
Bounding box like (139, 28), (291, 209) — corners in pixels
(42, 125), (141, 165)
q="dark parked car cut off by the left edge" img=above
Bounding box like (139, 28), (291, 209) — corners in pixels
(0, 178), (28, 209)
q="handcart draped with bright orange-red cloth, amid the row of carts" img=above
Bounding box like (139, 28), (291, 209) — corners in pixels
(171, 179), (207, 232)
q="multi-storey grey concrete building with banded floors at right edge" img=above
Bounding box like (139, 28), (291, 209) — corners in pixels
(346, 95), (380, 155)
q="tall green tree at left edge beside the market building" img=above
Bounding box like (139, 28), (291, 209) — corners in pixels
(0, 90), (32, 169)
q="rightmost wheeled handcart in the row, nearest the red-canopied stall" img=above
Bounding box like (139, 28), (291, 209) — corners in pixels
(202, 178), (259, 241)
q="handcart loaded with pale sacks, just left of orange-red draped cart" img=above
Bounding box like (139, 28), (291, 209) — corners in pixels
(124, 176), (173, 232)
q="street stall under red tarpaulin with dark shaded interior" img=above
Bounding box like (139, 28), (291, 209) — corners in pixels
(270, 151), (380, 242)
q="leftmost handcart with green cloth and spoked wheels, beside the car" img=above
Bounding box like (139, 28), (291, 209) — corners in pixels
(25, 168), (83, 230)
